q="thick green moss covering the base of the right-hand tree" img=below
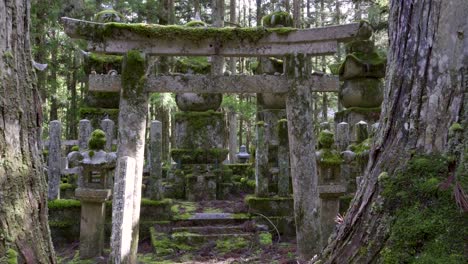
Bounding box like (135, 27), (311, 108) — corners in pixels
(379, 155), (468, 264)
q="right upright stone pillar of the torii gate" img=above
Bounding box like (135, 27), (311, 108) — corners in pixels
(285, 54), (323, 260)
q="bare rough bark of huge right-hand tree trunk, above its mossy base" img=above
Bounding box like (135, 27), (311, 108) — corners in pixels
(324, 0), (468, 263)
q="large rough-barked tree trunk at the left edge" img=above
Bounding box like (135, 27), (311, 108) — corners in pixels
(0, 0), (55, 263)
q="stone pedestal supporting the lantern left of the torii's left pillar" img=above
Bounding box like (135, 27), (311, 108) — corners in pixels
(75, 188), (111, 259)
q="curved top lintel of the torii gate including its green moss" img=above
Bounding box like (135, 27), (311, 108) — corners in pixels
(62, 17), (372, 57)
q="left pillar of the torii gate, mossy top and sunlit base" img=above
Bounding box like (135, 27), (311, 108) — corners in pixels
(110, 50), (148, 263)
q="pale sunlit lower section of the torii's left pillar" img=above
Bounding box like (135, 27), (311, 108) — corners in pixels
(110, 156), (136, 263)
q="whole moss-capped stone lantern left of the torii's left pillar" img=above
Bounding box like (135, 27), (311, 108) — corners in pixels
(75, 129), (117, 259)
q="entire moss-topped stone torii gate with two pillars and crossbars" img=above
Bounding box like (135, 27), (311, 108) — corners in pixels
(62, 18), (372, 263)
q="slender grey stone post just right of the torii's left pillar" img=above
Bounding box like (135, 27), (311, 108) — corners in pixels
(146, 121), (162, 200)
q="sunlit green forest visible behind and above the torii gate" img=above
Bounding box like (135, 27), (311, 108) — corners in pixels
(31, 0), (388, 154)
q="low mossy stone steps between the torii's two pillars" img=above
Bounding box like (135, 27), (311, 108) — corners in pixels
(150, 202), (272, 260)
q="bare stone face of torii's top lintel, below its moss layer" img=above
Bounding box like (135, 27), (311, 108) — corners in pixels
(62, 18), (371, 57)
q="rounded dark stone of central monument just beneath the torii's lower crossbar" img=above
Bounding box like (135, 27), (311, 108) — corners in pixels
(176, 93), (223, 112)
